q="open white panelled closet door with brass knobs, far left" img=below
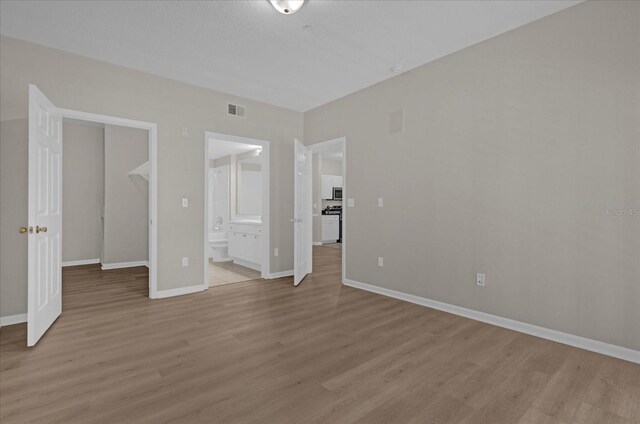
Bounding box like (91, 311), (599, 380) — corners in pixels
(26, 84), (62, 346)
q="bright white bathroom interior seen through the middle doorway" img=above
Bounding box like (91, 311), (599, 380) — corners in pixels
(207, 136), (266, 287)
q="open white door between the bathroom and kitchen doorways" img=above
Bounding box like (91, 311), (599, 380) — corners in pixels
(293, 139), (313, 286)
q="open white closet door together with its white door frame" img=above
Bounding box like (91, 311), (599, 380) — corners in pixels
(26, 84), (157, 346)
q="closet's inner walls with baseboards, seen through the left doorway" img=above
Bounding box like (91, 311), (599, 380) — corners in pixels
(62, 118), (149, 274)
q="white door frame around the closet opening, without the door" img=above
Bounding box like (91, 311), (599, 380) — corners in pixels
(60, 108), (158, 299)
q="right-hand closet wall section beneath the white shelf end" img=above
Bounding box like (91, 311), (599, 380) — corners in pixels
(102, 125), (149, 264)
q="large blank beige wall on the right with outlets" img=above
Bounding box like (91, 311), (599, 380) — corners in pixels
(304, 2), (640, 349)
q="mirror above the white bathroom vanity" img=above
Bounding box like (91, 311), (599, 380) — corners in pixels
(236, 154), (262, 219)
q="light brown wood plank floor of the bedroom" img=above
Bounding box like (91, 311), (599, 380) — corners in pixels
(0, 247), (640, 424)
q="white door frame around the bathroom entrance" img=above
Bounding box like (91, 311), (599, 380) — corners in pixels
(202, 131), (271, 290)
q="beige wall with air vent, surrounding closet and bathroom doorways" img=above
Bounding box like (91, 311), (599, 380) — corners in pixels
(0, 37), (302, 316)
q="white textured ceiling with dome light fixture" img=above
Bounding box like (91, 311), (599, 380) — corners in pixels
(0, 0), (578, 111)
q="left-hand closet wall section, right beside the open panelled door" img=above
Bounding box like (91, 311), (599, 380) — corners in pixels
(62, 121), (104, 262)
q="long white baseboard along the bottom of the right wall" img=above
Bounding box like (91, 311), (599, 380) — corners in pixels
(343, 278), (640, 364)
